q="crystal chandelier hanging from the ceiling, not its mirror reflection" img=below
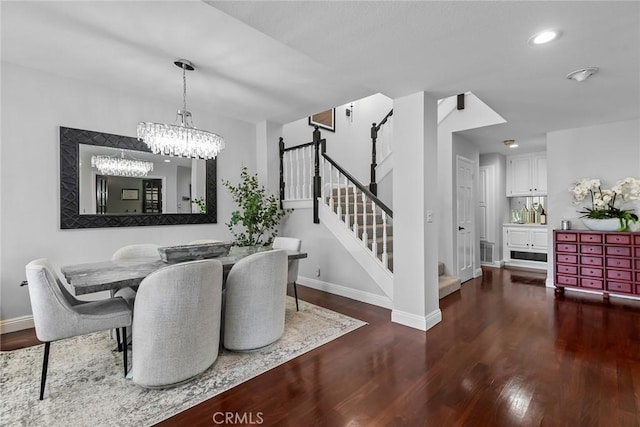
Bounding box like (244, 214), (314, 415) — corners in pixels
(138, 59), (224, 160)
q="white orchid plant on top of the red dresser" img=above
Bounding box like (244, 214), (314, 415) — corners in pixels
(569, 177), (640, 231)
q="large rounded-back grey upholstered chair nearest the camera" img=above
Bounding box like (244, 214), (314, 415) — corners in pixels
(131, 259), (222, 388)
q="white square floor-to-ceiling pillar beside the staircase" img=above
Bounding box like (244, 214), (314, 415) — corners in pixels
(391, 92), (442, 330)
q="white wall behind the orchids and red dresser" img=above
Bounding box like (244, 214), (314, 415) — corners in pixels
(547, 119), (640, 284)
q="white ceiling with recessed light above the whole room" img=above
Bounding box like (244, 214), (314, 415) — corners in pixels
(1, 1), (640, 152)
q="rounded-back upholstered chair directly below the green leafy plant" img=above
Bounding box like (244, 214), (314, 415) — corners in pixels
(223, 250), (287, 351)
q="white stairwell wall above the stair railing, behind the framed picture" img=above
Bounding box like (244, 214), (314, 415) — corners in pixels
(282, 94), (393, 185)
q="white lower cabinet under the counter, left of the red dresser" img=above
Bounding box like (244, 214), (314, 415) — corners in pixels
(503, 224), (549, 269)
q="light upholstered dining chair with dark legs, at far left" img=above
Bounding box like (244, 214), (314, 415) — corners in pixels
(25, 258), (131, 400)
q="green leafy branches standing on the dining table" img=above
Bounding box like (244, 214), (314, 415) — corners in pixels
(222, 166), (291, 246)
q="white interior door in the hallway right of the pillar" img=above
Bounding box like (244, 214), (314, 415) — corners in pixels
(456, 156), (475, 282)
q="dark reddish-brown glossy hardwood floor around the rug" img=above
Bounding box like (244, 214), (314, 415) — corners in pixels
(2, 269), (640, 427)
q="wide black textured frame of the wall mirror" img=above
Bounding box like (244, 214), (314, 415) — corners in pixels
(60, 126), (217, 229)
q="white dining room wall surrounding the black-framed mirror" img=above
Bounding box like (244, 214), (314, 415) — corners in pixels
(0, 62), (256, 320)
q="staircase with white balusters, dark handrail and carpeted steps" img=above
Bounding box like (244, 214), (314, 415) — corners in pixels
(279, 125), (460, 301)
